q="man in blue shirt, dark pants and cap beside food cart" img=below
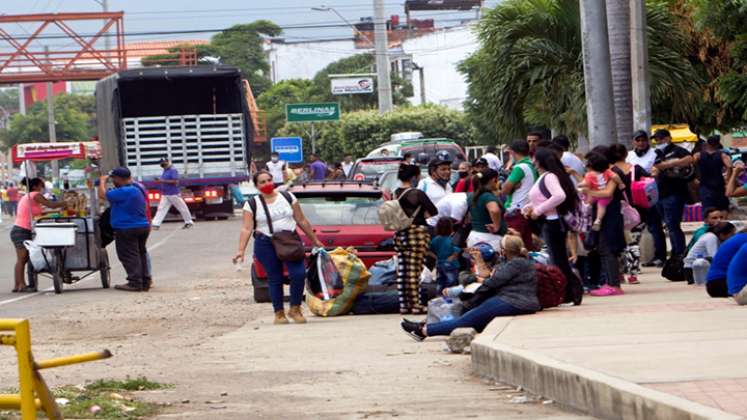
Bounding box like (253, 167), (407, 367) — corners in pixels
(99, 168), (150, 292)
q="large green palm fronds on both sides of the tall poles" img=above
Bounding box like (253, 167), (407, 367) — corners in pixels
(460, 0), (700, 144)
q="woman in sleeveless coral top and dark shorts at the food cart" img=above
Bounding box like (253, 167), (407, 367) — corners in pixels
(10, 178), (65, 293)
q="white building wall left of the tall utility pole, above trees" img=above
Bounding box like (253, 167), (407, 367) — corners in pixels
(267, 38), (368, 82)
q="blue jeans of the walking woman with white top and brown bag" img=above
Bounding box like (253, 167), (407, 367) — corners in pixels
(254, 233), (306, 312)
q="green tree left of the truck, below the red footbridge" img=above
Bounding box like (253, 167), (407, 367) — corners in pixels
(0, 95), (96, 147)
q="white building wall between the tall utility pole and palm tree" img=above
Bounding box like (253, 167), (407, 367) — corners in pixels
(402, 25), (478, 110)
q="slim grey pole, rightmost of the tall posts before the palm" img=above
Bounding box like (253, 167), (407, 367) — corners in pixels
(630, 0), (651, 133)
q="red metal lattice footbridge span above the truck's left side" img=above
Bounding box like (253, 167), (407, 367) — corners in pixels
(0, 12), (127, 84)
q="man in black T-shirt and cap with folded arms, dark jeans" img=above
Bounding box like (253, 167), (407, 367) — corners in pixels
(654, 129), (693, 256)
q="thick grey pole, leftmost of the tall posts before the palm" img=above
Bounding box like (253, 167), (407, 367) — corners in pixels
(580, 0), (617, 148)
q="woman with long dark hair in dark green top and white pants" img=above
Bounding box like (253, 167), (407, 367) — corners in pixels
(467, 168), (508, 251)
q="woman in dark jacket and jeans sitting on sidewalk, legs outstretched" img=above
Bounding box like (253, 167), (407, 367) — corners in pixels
(401, 235), (540, 341)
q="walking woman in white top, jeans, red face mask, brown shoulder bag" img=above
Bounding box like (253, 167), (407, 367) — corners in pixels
(233, 171), (324, 324)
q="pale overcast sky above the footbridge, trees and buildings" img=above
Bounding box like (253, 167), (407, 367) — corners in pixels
(0, 0), (500, 49)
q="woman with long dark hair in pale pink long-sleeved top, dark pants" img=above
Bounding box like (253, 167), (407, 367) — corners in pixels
(523, 147), (584, 305)
